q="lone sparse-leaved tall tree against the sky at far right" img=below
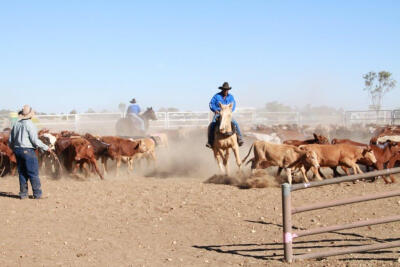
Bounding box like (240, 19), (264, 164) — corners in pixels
(363, 71), (397, 111)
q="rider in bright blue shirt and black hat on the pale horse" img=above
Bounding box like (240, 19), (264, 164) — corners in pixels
(206, 82), (244, 148)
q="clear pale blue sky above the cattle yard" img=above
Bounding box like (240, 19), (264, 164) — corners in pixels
(0, 0), (400, 113)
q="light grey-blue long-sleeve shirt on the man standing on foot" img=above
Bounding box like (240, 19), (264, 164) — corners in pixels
(8, 119), (49, 151)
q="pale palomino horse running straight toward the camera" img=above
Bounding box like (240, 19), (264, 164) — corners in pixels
(213, 103), (242, 175)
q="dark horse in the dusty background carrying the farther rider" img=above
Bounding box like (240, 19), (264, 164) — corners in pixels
(115, 107), (157, 136)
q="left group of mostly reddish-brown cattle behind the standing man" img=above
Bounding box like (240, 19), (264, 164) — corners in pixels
(0, 129), (166, 179)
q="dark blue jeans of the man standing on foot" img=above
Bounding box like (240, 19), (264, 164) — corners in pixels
(14, 147), (42, 198)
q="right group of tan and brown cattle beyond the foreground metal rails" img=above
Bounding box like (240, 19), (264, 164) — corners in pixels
(244, 125), (400, 183)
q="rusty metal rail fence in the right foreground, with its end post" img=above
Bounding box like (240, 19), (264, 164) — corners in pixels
(282, 168), (400, 262)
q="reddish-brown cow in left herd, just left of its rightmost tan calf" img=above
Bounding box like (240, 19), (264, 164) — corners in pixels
(100, 136), (146, 176)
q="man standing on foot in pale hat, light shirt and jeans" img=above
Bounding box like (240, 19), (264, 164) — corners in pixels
(8, 105), (53, 199)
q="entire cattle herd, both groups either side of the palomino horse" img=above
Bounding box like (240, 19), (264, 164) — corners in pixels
(0, 125), (400, 183)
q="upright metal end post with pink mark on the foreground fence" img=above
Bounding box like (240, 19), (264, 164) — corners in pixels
(282, 183), (293, 263)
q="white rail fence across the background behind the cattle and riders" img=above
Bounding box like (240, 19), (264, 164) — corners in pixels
(0, 110), (400, 134)
